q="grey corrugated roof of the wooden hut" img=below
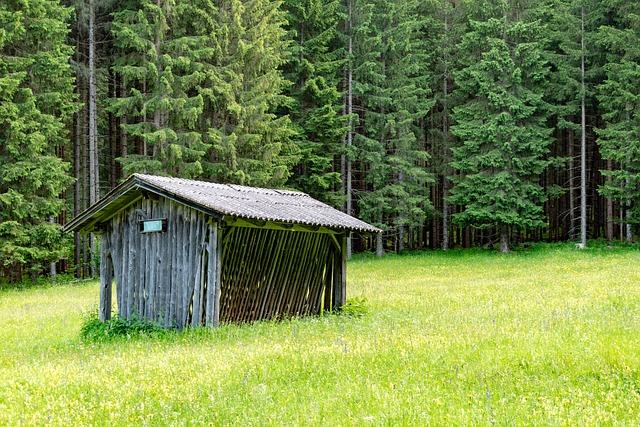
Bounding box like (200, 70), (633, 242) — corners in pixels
(68, 174), (381, 233)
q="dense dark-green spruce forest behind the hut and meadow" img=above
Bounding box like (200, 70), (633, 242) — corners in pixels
(0, 0), (640, 282)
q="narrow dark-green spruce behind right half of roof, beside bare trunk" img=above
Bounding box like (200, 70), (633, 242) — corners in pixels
(283, 0), (346, 206)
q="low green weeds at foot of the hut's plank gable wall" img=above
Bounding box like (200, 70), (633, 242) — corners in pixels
(80, 311), (168, 342)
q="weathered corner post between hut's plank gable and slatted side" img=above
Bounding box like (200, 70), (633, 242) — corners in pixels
(205, 223), (223, 326)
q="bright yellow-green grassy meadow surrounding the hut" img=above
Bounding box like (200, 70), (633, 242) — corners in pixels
(0, 245), (640, 426)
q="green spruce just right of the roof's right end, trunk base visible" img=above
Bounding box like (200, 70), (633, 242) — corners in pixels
(354, 0), (434, 250)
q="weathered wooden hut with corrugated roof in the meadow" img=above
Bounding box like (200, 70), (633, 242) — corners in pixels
(65, 174), (380, 328)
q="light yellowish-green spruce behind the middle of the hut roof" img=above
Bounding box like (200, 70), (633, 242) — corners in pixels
(201, 0), (299, 186)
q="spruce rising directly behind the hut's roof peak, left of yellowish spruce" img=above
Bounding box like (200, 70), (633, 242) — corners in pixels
(110, 0), (210, 177)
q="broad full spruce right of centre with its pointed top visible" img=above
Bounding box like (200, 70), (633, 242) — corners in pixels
(450, 9), (551, 252)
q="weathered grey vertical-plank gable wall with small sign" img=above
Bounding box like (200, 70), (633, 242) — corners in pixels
(102, 198), (216, 327)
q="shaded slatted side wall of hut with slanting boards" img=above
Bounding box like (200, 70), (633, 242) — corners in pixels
(220, 227), (335, 322)
